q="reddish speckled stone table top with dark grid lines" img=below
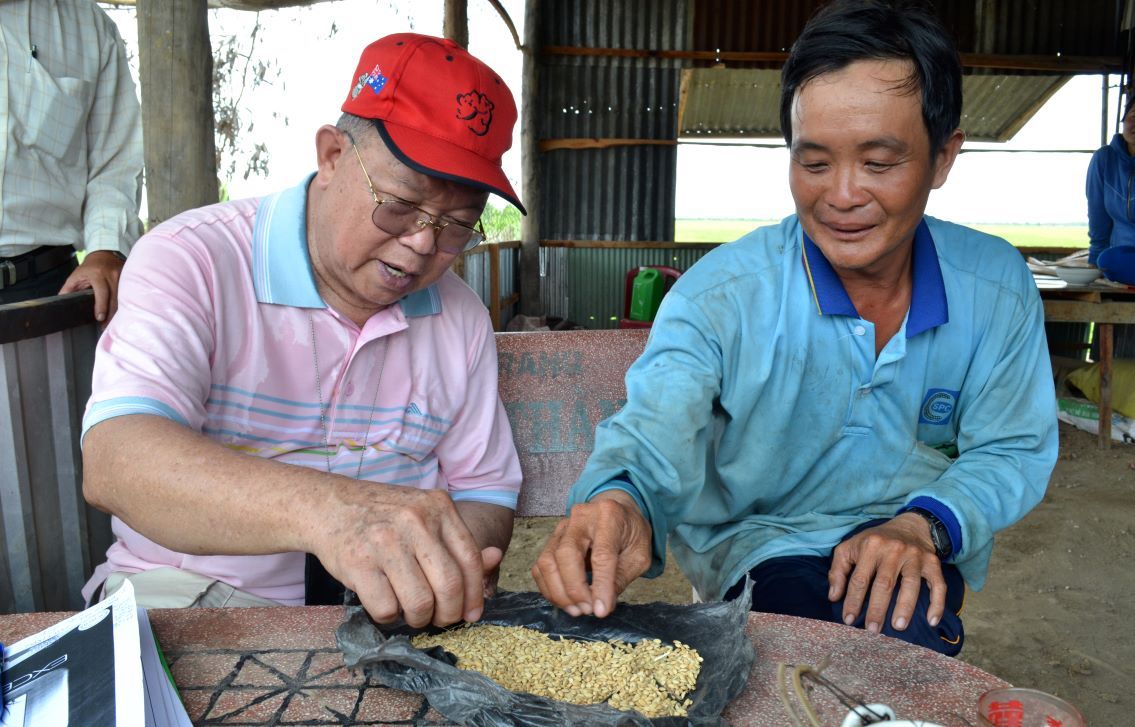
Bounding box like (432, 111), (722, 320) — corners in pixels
(0, 606), (1007, 727)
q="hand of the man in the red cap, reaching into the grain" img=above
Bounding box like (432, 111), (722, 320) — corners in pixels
(312, 481), (494, 627)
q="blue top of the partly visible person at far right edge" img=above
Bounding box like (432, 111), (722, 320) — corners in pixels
(1085, 134), (1135, 265)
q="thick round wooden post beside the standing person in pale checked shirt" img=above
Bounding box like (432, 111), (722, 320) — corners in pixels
(137, 0), (217, 227)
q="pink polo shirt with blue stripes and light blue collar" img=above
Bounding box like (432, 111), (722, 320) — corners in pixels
(83, 177), (521, 605)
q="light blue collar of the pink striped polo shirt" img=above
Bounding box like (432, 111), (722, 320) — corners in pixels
(252, 174), (442, 318)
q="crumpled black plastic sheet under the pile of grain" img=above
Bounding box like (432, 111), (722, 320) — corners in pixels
(336, 584), (756, 727)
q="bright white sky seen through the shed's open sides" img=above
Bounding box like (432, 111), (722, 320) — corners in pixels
(108, 0), (1118, 225)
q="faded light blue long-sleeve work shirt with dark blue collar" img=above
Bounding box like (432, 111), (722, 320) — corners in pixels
(569, 217), (1057, 598)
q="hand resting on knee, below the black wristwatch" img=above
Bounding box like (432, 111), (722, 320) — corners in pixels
(827, 513), (945, 633)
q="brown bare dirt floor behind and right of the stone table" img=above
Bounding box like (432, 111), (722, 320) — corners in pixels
(501, 424), (1135, 726)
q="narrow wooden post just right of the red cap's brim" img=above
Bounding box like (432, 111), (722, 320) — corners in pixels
(520, 0), (544, 315)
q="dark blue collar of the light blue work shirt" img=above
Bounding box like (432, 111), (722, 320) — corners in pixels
(801, 219), (950, 338)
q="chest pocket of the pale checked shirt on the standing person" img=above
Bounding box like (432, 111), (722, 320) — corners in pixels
(10, 60), (94, 163)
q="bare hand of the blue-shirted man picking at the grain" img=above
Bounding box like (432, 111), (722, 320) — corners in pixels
(532, 490), (650, 618)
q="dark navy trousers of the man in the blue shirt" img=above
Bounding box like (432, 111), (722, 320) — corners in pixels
(725, 521), (966, 657)
